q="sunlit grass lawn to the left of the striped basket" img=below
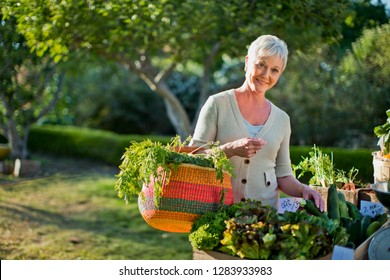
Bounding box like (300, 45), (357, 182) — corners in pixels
(0, 155), (192, 260)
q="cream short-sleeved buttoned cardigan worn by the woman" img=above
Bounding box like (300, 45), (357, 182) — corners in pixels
(191, 90), (293, 208)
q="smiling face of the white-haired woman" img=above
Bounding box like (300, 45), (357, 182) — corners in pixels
(245, 56), (283, 93)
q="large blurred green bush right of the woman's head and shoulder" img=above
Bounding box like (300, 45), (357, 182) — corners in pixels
(269, 24), (390, 148)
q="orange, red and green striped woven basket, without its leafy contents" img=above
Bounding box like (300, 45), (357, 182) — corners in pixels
(138, 164), (233, 233)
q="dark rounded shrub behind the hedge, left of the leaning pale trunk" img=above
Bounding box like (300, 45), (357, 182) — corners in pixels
(59, 57), (175, 135)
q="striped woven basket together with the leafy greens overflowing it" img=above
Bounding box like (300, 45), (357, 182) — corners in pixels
(115, 136), (233, 232)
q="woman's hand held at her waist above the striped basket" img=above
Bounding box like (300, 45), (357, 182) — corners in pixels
(221, 137), (267, 158)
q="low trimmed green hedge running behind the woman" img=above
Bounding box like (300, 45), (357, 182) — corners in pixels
(28, 125), (374, 182)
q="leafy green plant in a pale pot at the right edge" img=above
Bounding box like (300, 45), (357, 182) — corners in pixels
(372, 109), (390, 182)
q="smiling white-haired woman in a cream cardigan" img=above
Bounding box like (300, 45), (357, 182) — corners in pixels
(191, 35), (324, 211)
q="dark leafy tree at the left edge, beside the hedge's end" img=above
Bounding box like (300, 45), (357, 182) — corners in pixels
(0, 14), (63, 159)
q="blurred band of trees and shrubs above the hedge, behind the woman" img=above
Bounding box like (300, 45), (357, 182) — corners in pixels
(0, 0), (390, 158)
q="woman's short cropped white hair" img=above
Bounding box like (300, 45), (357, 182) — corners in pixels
(248, 35), (288, 70)
